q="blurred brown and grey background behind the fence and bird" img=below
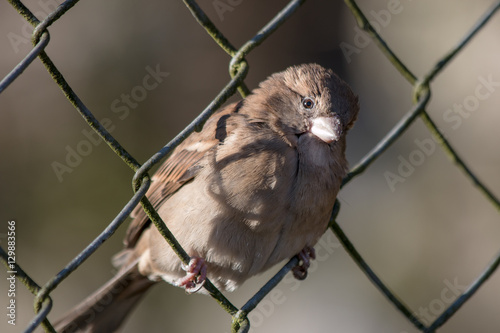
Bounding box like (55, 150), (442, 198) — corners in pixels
(0, 0), (500, 333)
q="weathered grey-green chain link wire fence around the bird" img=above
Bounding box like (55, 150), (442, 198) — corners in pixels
(0, 0), (500, 332)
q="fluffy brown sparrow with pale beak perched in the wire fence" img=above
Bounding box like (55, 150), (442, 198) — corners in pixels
(55, 64), (359, 333)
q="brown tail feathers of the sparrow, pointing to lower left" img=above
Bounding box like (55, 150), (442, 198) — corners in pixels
(54, 263), (155, 333)
